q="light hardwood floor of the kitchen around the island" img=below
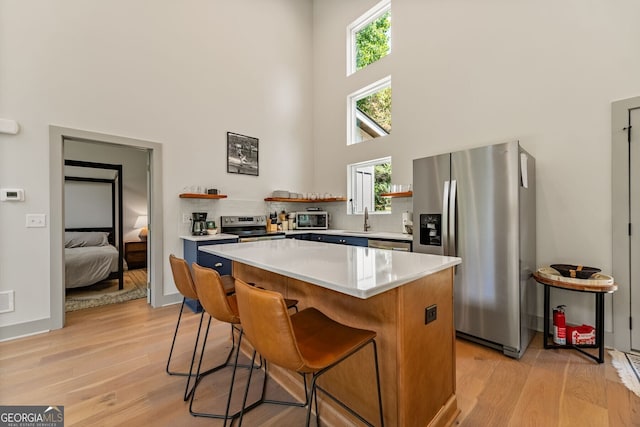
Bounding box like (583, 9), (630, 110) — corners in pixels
(0, 300), (640, 427)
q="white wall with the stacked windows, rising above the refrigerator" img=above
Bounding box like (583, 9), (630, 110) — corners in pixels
(314, 0), (640, 331)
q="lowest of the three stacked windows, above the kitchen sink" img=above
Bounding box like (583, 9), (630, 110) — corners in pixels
(348, 157), (391, 214)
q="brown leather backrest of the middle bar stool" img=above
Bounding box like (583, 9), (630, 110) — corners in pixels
(191, 262), (240, 324)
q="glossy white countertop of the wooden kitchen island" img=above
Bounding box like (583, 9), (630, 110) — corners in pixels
(199, 239), (461, 299)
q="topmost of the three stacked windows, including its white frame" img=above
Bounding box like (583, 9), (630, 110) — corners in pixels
(347, 0), (391, 75)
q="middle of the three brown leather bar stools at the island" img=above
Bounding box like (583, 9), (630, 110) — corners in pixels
(189, 262), (298, 426)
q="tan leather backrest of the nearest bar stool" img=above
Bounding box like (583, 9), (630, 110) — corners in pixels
(236, 279), (306, 372)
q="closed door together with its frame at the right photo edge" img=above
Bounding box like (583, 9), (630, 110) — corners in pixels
(611, 97), (640, 352)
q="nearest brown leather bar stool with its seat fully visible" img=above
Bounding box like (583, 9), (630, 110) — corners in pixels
(236, 279), (384, 426)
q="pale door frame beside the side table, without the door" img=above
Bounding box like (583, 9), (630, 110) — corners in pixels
(611, 96), (640, 351)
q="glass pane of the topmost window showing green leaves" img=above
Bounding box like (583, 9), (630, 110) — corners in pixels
(355, 11), (391, 70)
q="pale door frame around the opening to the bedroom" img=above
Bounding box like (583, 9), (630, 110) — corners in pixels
(49, 125), (166, 329)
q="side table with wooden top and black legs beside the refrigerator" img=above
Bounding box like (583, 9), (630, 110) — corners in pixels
(533, 272), (618, 363)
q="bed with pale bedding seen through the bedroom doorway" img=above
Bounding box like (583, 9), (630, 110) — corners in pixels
(64, 231), (119, 289)
